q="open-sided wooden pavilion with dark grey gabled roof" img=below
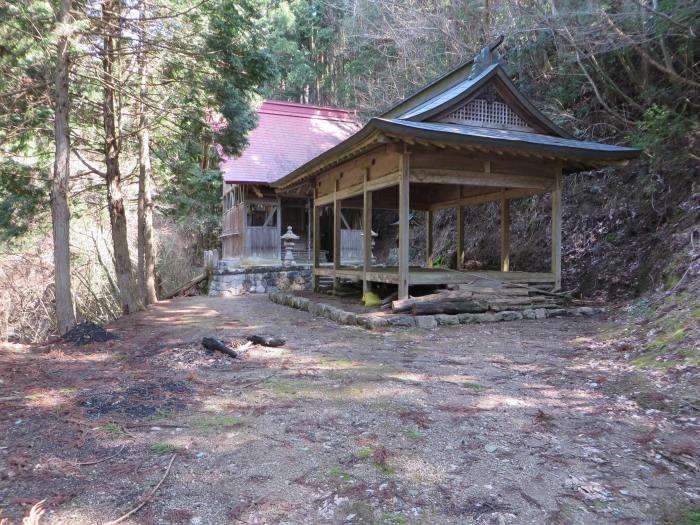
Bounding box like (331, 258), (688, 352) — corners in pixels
(272, 42), (639, 299)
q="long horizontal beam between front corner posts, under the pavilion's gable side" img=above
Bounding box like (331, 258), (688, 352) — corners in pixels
(411, 169), (554, 190)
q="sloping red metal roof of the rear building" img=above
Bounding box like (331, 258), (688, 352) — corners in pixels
(219, 100), (360, 184)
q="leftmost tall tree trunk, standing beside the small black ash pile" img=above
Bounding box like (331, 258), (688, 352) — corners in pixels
(51, 0), (75, 335)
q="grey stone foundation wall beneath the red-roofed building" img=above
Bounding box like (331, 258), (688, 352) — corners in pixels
(209, 262), (312, 297)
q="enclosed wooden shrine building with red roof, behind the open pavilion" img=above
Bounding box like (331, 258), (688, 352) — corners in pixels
(219, 101), (361, 265)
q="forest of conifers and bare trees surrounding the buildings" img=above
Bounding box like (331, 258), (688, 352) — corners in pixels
(0, 0), (700, 340)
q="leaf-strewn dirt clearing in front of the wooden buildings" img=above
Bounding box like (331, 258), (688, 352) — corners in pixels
(0, 296), (700, 525)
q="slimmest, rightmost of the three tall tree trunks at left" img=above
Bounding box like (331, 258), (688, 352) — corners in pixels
(138, 2), (158, 304)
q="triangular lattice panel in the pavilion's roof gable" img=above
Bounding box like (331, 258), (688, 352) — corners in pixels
(439, 85), (534, 131)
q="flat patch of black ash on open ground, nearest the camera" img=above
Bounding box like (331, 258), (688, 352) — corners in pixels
(78, 381), (192, 419)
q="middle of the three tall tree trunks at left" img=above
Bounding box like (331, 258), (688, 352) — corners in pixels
(102, 0), (138, 314)
